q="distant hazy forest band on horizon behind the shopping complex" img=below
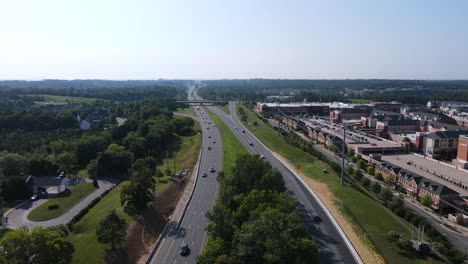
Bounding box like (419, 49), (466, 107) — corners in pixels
(198, 79), (468, 104)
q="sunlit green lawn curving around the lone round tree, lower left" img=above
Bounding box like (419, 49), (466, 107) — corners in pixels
(69, 182), (133, 264)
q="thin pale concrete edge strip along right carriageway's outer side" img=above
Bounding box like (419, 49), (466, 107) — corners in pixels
(232, 102), (364, 264)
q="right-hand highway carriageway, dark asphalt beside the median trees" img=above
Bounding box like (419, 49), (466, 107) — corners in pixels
(210, 102), (356, 263)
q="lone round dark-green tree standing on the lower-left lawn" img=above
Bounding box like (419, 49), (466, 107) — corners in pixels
(96, 210), (127, 249)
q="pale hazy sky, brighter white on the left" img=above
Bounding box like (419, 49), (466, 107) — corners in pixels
(0, 0), (468, 79)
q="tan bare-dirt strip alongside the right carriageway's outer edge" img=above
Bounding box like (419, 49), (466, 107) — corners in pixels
(273, 152), (385, 263)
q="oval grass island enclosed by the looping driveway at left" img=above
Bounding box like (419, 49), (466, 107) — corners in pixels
(28, 182), (94, 221)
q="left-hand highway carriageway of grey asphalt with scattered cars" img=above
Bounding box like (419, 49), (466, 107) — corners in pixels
(151, 83), (223, 264)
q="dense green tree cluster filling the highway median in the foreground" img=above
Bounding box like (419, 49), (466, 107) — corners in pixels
(197, 155), (319, 264)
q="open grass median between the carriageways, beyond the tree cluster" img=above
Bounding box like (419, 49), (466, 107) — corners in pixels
(208, 110), (248, 173)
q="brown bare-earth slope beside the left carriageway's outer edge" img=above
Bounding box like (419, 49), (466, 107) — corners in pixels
(124, 180), (187, 263)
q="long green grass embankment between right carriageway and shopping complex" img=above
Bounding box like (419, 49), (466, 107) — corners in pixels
(238, 104), (440, 263)
